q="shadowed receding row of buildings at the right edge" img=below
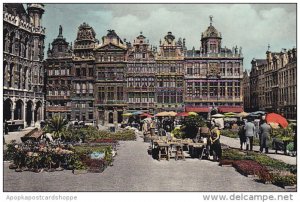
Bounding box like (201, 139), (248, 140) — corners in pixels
(250, 48), (297, 119)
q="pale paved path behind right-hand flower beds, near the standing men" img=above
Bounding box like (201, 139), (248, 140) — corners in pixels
(221, 136), (297, 165)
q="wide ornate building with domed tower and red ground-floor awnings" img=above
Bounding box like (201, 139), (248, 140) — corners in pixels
(184, 16), (243, 114)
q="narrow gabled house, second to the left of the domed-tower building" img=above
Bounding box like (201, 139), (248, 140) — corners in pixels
(125, 32), (156, 113)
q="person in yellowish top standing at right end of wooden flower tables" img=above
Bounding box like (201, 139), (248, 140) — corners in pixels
(210, 122), (222, 161)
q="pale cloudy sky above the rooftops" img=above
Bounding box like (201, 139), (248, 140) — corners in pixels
(39, 4), (296, 69)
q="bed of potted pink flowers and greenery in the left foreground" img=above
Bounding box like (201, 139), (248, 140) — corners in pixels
(6, 142), (113, 172)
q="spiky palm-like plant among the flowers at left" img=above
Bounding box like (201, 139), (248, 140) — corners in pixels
(45, 115), (68, 138)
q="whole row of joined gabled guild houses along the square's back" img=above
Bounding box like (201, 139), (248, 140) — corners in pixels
(47, 18), (243, 125)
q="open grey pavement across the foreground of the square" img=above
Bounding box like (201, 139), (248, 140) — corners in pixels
(4, 133), (284, 192)
